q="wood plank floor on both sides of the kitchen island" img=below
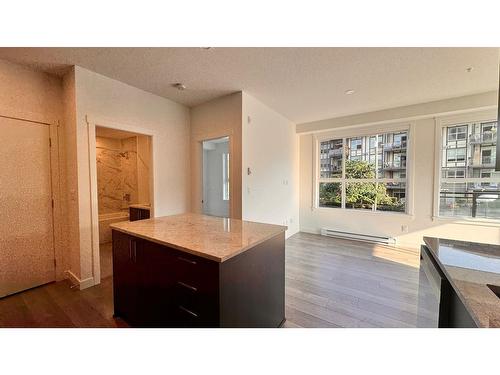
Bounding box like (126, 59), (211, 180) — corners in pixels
(0, 233), (435, 327)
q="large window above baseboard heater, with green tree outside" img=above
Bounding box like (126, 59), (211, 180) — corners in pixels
(317, 130), (408, 212)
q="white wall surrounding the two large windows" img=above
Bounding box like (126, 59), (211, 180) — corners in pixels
(300, 93), (500, 248)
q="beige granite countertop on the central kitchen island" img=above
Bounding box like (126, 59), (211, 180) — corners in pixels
(110, 213), (287, 262)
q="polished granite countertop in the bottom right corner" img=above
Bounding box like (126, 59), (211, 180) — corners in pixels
(424, 237), (500, 327)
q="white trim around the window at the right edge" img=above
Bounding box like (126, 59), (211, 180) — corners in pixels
(432, 109), (500, 223)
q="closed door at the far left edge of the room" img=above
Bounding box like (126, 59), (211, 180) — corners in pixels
(0, 117), (55, 297)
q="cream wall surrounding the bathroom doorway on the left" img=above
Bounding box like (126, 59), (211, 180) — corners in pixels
(75, 67), (190, 280)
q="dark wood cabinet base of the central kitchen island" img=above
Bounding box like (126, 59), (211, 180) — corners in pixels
(113, 230), (285, 327)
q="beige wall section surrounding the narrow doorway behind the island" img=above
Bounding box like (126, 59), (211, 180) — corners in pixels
(191, 92), (242, 219)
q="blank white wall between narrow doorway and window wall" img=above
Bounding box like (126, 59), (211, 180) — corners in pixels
(242, 93), (299, 237)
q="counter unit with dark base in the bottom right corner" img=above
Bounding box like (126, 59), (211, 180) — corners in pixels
(421, 237), (500, 328)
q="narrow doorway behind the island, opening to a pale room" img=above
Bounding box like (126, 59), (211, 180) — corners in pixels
(202, 137), (231, 217)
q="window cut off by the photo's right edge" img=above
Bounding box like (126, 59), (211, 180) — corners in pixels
(438, 121), (500, 219)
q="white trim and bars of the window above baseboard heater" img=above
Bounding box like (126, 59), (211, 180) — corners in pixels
(311, 121), (415, 218)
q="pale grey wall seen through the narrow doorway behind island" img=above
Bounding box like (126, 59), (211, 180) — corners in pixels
(203, 141), (231, 217)
